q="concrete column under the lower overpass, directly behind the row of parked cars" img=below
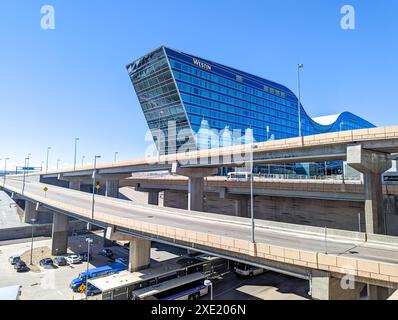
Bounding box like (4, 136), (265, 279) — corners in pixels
(51, 212), (69, 256)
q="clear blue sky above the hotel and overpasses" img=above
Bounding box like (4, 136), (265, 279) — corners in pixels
(0, 0), (398, 168)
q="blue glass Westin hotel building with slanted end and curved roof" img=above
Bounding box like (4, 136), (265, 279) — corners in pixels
(127, 46), (374, 172)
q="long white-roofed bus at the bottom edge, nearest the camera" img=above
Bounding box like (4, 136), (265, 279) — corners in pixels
(133, 272), (208, 300)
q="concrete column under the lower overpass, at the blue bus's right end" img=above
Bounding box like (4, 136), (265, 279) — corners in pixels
(129, 237), (151, 272)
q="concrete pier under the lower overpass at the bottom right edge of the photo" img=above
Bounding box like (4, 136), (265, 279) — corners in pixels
(311, 271), (365, 300)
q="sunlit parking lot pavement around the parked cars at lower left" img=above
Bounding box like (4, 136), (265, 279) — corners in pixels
(0, 234), (185, 300)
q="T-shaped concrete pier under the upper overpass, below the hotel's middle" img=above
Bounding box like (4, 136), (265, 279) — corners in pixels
(171, 164), (218, 211)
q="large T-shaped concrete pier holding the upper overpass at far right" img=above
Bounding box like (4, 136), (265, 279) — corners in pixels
(347, 144), (392, 234)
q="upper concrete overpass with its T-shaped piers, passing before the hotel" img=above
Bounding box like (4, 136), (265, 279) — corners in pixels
(18, 126), (398, 234)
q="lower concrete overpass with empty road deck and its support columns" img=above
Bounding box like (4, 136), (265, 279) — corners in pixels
(3, 177), (398, 299)
